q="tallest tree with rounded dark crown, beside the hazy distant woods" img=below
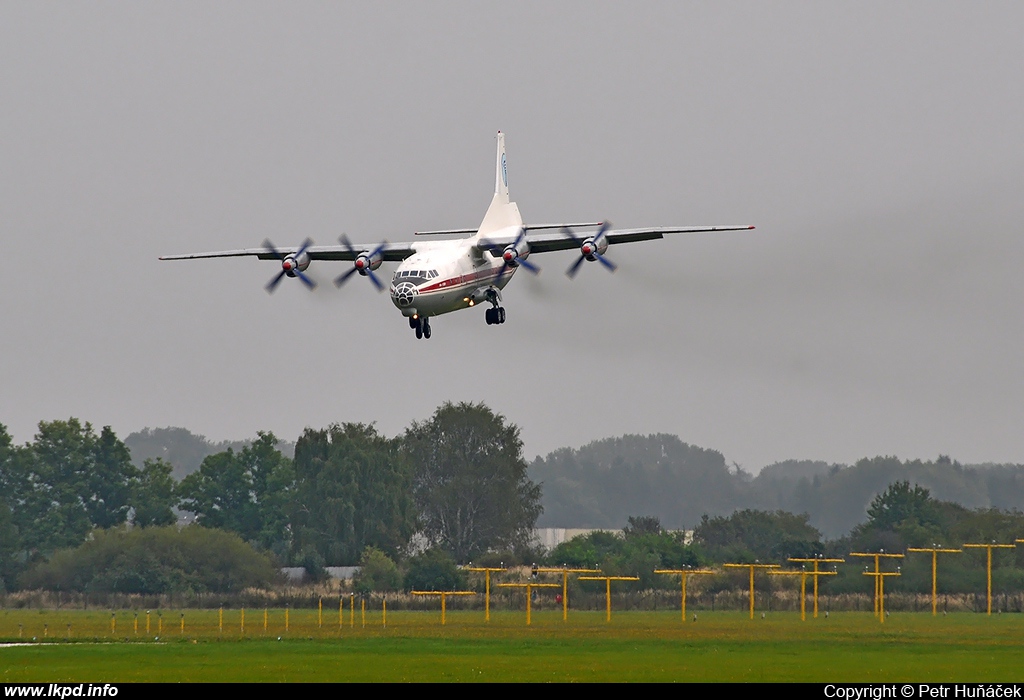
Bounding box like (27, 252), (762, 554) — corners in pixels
(403, 403), (542, 562)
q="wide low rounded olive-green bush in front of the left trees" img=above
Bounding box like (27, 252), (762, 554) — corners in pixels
(20, 525), (280, 594)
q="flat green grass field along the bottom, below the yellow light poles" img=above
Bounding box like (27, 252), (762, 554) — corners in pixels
(0, 610), (1024, 683)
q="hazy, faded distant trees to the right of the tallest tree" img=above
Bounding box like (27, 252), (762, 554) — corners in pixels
(529, 434), (1024, 538)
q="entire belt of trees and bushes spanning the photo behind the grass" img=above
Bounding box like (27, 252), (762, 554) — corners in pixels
(0, 403), (1024, 592)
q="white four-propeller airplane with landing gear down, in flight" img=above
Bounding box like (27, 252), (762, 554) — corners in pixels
(160, 131), (754, 338)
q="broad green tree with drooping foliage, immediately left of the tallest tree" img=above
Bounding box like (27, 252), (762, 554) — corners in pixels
(292, 423), (416, 566)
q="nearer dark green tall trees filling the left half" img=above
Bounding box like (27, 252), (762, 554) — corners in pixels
(0, 403), (541, 588)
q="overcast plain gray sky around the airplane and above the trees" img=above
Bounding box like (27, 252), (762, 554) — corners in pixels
(0, 2), (1024, 471)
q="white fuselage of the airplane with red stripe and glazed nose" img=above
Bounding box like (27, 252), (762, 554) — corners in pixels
(389, 236), (518, 317)
